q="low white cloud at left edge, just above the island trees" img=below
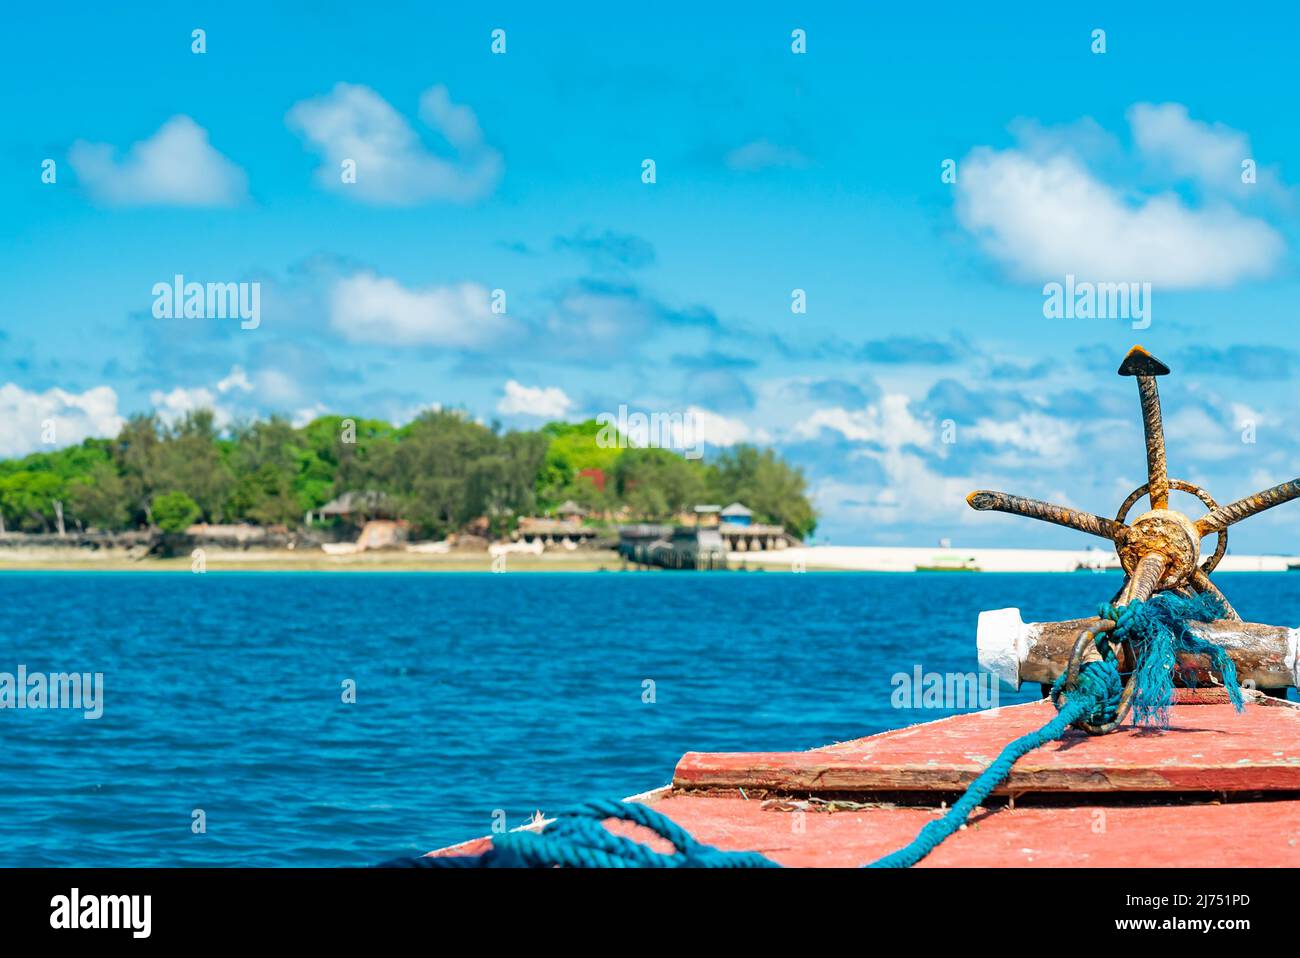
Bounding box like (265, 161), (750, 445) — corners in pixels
(0, 382), (125, 458)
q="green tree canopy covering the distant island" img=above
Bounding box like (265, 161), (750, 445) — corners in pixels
(0, 409), (816, 537)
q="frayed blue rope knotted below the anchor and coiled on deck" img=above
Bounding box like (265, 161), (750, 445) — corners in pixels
(381, 593), (1243, 868)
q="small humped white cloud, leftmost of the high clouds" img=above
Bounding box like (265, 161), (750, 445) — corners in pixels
(68, 116), (248, 207)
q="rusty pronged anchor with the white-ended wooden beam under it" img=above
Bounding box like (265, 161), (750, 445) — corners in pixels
(966, 346), (1300, 695)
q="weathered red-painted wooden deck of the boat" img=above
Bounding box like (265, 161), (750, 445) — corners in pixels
(434, 694), (1300, 867)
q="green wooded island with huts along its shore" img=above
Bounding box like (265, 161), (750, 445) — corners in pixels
(0, 409), (816, 568)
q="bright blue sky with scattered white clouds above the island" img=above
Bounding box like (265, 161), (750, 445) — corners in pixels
(0, 3), (1300, 551)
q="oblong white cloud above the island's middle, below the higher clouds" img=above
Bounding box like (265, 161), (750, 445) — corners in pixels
(329, 273), (510, 348)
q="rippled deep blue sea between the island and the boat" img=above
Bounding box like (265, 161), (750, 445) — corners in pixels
(0, 572), (1300, 866)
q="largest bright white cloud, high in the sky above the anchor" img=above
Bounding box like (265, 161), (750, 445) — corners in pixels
(957, 108), (1286, 289)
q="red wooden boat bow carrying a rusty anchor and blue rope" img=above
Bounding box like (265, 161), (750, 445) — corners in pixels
(416, 347), (1300, 867)
